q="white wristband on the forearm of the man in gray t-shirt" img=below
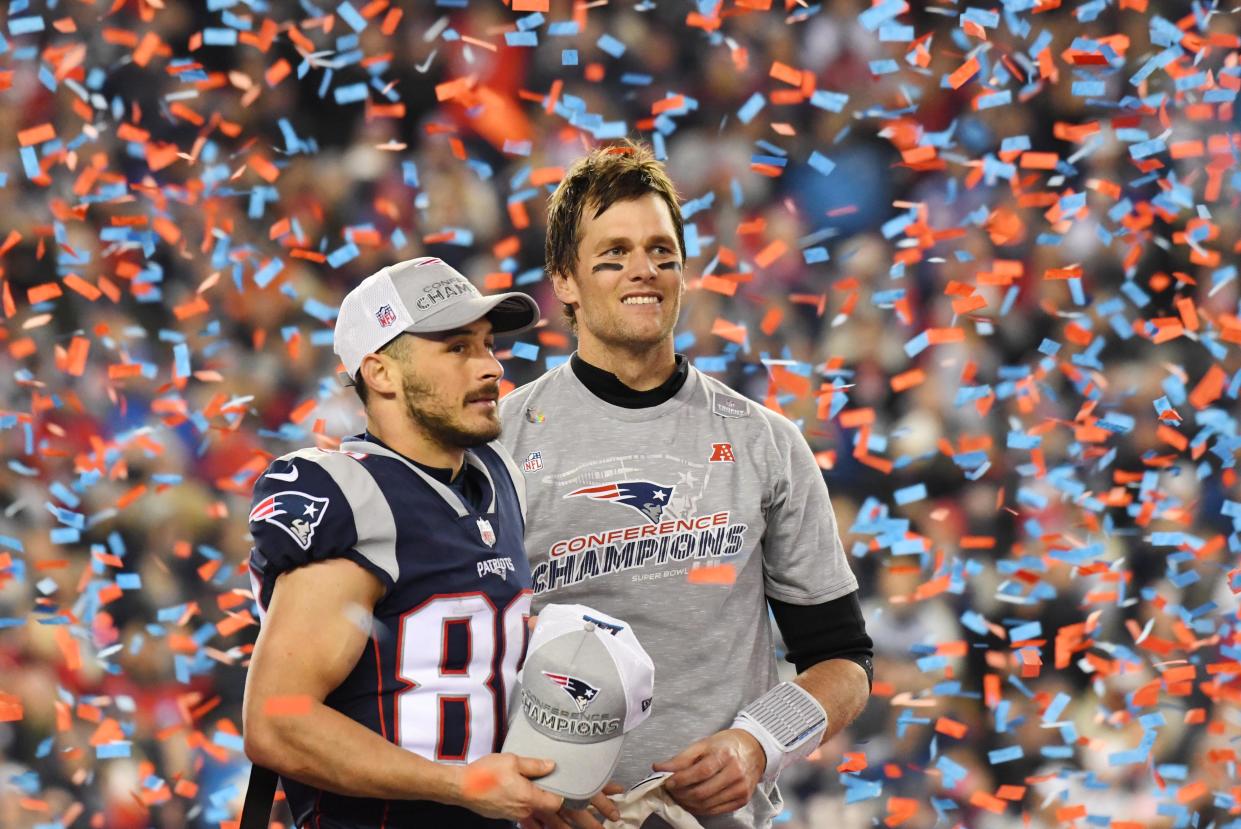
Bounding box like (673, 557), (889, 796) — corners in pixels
(732, 683), (828, 787)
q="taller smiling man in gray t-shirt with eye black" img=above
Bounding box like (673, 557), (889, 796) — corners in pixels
(500, 141), (872, 829)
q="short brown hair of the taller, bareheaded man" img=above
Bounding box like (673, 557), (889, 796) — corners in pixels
(544, 138), (685, 325)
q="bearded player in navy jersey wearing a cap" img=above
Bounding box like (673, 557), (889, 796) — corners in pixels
(244, 258), (561, 829)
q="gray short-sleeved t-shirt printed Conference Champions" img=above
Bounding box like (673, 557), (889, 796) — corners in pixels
(500, 362), (858, 829)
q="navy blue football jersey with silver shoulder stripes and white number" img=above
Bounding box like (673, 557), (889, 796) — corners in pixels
(249, 439), (530, 829)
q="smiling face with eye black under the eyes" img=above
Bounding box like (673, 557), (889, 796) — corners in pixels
(553, 192), (685, 351)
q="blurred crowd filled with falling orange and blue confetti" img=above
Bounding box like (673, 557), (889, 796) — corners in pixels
(0, 0), (1241, 829)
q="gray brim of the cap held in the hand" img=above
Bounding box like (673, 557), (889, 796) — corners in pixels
(503, 709), (624, 800)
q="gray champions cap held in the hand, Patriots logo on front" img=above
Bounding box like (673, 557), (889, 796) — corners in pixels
(504, 604), (655, 804)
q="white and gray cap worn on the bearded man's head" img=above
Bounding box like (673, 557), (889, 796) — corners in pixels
(333, 256), (539, 380)
